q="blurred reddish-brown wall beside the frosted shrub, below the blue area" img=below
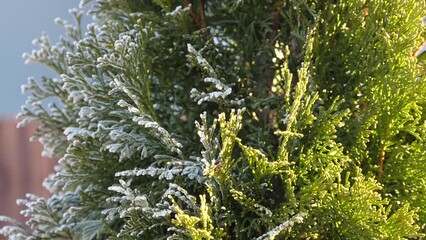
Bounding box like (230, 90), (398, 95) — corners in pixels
(0, 119), (55, 239)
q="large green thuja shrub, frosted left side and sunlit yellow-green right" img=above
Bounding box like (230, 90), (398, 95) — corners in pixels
(1, 0), (426, 240)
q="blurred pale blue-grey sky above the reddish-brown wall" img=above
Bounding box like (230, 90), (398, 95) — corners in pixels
(0, 0), (81, 117)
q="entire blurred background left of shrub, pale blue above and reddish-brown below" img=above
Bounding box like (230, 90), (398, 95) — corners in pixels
(0, 0), (80, 234)
